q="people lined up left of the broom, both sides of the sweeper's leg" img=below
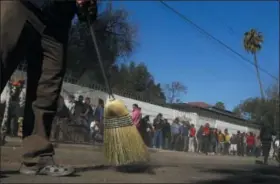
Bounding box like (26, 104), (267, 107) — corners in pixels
(0, 80), (104, 144)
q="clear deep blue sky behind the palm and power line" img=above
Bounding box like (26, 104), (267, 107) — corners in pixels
(110, 1), (279, 110)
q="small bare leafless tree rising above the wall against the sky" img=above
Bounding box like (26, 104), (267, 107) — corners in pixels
(165, 81), (187, 103)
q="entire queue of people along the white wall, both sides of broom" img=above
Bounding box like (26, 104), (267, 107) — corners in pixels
(2, 81), (278, 165)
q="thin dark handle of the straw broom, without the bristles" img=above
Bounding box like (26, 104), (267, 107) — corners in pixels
(87, 16), (115, 99)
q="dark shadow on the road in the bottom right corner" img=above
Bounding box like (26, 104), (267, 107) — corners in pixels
(194, 165), (280, 184)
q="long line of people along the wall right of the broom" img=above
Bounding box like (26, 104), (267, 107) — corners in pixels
(132, 104), (276, 165)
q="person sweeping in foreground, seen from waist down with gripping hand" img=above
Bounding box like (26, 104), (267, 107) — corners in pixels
(0, 0), (97, 176)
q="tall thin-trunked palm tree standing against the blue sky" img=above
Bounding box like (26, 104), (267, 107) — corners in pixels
(243, 29), (264, 99)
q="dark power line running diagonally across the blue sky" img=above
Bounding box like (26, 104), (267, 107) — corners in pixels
(159, 0), (278, 81)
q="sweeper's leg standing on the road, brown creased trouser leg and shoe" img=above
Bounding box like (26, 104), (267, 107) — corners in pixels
(22, 26), (73, 175)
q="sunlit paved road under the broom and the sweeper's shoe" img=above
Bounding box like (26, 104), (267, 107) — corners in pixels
(1, 139), (280, 184)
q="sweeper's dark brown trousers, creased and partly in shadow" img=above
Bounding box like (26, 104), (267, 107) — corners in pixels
(0, 0), (68, 163)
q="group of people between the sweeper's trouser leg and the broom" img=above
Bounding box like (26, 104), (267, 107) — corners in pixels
(52, 95), (104, 143)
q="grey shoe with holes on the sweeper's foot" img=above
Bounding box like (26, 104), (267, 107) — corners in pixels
(19, 157), (75, 177)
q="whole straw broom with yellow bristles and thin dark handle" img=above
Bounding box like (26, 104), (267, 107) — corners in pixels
(88, 17), (149, 166)
